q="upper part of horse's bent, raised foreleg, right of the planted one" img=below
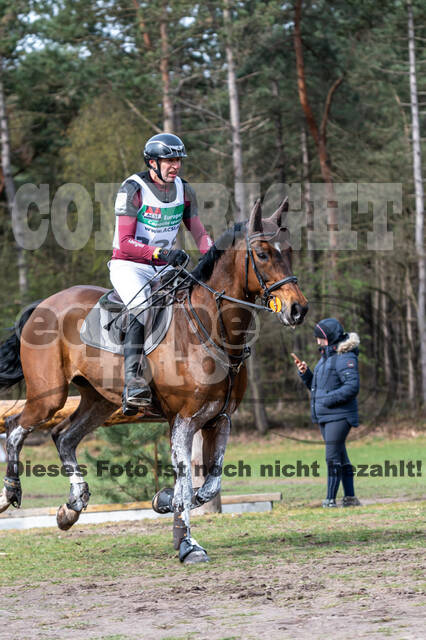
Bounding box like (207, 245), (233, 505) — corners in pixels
(193, 415), (231, 507)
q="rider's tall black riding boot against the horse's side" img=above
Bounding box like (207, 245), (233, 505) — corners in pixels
(123, 314), (152, 416)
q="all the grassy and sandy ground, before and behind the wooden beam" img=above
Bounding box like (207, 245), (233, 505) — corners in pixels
(0, 432), (426, 640)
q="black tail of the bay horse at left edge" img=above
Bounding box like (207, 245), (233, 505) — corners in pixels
(0, 300), (41, 390)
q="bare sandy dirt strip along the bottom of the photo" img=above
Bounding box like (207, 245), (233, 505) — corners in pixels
(0, 549), (425, 640)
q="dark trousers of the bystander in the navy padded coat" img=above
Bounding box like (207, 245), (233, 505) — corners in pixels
(320, 420), (355, 499)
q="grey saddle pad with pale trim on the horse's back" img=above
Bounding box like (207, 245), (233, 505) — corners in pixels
(80, 301), (173, 355)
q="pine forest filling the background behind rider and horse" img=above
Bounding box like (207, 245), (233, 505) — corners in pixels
(0, 0), (426, 431)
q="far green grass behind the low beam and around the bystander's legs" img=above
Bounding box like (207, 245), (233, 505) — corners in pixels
(0, 434), (426, 507)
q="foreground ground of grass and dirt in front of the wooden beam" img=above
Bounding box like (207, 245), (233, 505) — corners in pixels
(0, 501), (426, 640)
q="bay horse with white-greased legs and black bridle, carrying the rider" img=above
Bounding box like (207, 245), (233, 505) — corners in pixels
(0, 201), (307, 562)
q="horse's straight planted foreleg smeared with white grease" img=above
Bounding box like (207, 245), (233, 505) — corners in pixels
(171, 416), (209, 563)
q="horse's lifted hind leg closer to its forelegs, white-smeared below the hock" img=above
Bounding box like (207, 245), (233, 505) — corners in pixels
(52, 387), (117, 530)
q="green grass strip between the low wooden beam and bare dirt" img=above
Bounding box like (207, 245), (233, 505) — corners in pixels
(0, 502), (426, 588)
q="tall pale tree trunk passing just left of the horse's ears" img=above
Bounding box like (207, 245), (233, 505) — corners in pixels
(223, 0), (268, 433)
